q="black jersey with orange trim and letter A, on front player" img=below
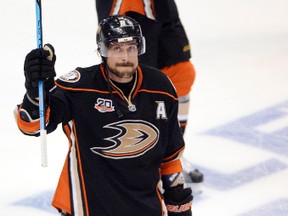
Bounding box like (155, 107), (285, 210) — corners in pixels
(18, 65), (184, 216)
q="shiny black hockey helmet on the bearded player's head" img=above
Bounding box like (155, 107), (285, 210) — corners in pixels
(96, 15), (146, 57)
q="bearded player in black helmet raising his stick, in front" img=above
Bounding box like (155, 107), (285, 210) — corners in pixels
(17, 15), (193, 216)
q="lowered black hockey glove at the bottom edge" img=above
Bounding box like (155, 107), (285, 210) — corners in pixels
(163, 185), (193, 216)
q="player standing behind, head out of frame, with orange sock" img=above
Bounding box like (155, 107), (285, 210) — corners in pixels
(95, 0), (203, 183)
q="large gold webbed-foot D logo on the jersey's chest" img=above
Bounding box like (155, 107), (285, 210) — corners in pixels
(91, 120), (159, 159)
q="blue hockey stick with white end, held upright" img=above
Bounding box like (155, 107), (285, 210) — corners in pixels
(36, 0), (48, 167)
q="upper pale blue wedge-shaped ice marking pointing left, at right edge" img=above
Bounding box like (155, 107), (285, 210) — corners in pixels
(207, 101), (288, 156)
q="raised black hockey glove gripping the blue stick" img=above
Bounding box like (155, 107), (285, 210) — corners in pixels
(24, 44), (56, 99)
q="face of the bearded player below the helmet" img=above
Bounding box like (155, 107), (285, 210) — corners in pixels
(107, 40), (138, 82)
